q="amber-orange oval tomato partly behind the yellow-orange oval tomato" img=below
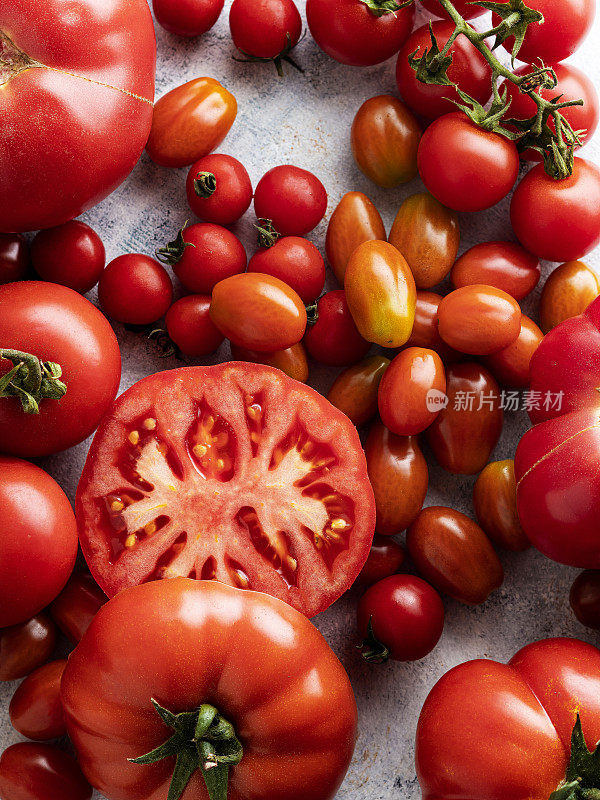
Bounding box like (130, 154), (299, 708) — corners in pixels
(389, 192), (460, 289)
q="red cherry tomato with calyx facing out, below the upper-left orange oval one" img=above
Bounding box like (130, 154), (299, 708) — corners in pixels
(186, 153), (252, 225)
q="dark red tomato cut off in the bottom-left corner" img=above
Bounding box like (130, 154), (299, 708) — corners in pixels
(0, 742), (92, 800)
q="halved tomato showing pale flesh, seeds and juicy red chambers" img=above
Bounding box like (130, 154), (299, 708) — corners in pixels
(77, 362), (375, 616)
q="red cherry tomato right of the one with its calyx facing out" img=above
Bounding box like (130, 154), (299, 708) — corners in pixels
(254, 164), (327, 236)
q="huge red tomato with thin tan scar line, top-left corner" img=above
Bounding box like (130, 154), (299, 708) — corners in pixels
(0, 0), (156, 231)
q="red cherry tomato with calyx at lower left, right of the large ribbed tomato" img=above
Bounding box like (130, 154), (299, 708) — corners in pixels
(357, 575), (444, 664)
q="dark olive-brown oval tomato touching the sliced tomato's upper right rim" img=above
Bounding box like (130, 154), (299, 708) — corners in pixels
(327, 355), (390, 427)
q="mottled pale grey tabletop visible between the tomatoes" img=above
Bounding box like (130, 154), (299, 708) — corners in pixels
(0, 0), (600, 800)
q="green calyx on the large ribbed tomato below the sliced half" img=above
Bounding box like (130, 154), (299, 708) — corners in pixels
(128, 700), (244, 800)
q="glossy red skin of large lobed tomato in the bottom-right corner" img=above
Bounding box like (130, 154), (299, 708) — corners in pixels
(415, 639), (600, 800)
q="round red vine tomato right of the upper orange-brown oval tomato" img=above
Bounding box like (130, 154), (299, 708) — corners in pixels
(418, 111), (519, 211)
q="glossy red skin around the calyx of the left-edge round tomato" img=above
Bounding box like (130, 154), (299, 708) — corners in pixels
(0, 281), (121, 458)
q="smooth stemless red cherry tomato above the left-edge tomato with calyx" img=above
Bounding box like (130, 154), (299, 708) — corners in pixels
(98, 253), (173, 325)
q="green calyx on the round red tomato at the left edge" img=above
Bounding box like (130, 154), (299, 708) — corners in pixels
(0, 350), (67, 414)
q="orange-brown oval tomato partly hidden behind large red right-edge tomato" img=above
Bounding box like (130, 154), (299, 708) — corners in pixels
(473, 458), (531, 552)
